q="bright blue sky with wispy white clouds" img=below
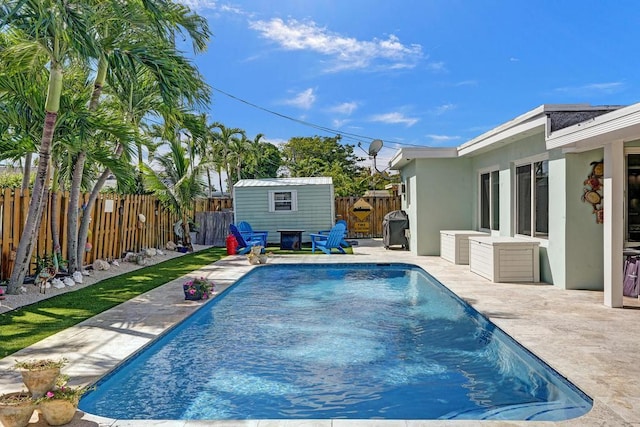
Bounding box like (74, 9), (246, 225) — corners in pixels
(179, 0), (640, 169)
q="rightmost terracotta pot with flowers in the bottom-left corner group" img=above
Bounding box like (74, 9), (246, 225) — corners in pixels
(36, 375), (87, 426)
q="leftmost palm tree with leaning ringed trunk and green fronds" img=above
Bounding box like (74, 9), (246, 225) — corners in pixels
(0, 0), (99, 293)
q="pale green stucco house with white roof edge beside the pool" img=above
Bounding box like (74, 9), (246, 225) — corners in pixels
(390, 104), (640, 307)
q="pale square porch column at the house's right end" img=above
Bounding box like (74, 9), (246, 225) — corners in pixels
(602, 141), (625, 308)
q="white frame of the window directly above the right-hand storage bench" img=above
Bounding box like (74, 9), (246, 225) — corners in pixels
(512, 155), (549, 240)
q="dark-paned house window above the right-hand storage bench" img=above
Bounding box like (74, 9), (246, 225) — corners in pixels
(516, 160), (549, 238)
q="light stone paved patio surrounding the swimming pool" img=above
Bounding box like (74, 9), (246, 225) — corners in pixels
(0, 240), (640, 427)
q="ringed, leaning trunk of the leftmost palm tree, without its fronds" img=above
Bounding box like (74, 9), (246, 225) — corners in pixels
(7, 62), (62, 294)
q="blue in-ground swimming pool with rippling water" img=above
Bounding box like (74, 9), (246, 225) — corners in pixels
(79, 264), (592, 421)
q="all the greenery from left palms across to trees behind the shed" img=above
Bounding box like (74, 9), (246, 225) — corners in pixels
(0, 0), (398, 293)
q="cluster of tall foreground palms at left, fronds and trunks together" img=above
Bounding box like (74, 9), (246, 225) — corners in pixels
(0, 0), (210, 293)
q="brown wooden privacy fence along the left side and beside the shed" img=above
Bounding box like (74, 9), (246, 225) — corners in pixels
(0, 188), (401, 280)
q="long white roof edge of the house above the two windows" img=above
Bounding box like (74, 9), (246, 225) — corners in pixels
(389, 104), (620, 169)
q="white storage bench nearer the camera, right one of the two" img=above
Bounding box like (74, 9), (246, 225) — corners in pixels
(469, 236), (540, 282)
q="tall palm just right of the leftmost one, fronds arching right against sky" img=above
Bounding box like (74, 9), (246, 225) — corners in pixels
(69, 0), (210, 271)
